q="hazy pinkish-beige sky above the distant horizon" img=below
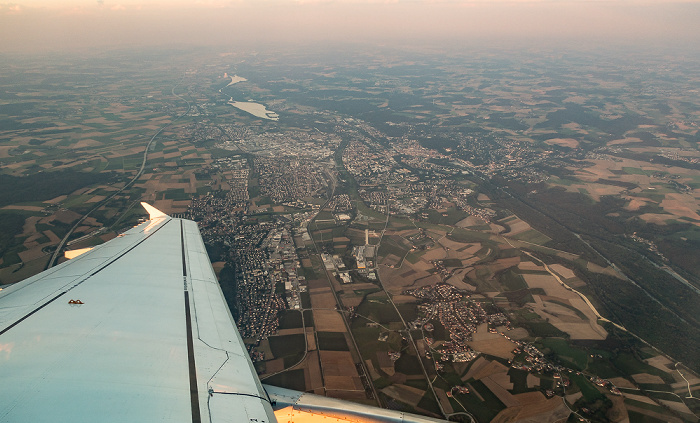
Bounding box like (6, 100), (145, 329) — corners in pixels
(0, 0), (700, 52)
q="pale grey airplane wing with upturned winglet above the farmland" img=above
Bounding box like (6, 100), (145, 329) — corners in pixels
(0, 205), (442, 423)
